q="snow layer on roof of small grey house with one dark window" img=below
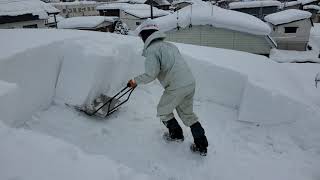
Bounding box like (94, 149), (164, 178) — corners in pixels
(264, 9), (312, 25)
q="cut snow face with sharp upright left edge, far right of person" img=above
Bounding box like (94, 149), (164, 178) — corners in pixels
(238, 82), (307, 124)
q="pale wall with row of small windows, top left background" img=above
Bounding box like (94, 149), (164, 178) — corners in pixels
(53, 3), (99, 17)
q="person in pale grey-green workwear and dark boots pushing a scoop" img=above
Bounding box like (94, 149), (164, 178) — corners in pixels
(128, 19), (208, 155)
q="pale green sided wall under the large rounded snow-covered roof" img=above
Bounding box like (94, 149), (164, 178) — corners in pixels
(166, 26), (271, 55)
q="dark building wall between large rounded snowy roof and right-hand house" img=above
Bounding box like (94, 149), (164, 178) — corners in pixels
(232, 6), (278, 20)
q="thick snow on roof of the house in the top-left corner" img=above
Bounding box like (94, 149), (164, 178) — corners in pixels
(0, 0), (60, 19)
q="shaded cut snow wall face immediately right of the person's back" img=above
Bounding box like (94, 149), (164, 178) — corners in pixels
(185, 56), (248, 109)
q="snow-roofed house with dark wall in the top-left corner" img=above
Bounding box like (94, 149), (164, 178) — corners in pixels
(0, 0), (59, 29)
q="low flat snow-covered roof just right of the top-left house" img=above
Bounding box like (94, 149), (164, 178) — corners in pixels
(58, 16), (118, 29)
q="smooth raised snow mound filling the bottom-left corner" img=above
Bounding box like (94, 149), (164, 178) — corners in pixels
(0, 121), (154, 180)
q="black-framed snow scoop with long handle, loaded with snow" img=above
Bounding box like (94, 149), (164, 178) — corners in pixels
(66, 84), (135, 118)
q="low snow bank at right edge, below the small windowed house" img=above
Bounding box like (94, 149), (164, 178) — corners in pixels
(270, 49), (320, 63)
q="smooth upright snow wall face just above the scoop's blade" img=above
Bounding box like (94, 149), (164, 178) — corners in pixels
(55, 51), (115, 105)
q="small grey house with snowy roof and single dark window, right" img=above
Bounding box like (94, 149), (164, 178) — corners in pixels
(265, 9), (313, 51)
